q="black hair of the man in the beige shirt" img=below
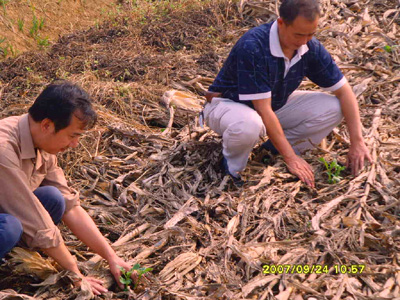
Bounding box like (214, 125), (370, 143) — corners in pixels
(29, 80), (97, 132)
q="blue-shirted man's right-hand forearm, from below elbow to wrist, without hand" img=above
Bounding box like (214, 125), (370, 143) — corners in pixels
(334, 83), (364, 144)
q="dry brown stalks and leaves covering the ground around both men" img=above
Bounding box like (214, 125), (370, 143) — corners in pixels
(0, 0), (400, 300)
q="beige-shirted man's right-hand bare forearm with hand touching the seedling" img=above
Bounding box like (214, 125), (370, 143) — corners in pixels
(63, 206), (135, 288)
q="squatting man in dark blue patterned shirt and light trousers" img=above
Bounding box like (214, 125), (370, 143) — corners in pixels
(203, 0), (371, 187)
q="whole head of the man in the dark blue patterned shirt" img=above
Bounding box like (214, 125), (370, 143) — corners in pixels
(278, 0), (321, 51)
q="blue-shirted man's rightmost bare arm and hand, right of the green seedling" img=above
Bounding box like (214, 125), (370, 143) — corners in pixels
(333, 82), (372, 175)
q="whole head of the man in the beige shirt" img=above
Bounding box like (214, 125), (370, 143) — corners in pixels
(29, 81), (97, 154)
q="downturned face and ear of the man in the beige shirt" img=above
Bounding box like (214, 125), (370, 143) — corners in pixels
(40, 115), (85, 154)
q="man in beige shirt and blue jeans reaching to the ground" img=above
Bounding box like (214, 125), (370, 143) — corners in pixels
(0, 81), (134, 295)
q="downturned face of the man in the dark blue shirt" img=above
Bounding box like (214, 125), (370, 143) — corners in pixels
(278, 16), (319, 51)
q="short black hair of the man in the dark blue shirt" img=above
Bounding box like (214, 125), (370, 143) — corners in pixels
(279, 0), (321, 25)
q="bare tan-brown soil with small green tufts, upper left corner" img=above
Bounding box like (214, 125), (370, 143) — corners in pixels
(0, 0), (120, 56)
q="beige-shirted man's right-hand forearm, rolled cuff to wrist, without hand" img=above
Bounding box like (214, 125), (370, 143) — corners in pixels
(63, 206), (116, 261)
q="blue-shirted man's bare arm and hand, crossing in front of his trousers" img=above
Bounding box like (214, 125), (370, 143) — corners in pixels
(252, 98), (315, 187)
